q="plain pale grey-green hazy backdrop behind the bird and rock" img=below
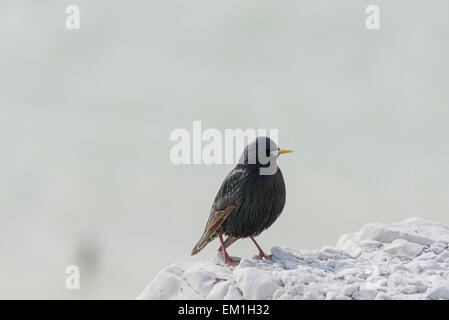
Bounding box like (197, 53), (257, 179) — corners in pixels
(0, 0), (449, 299)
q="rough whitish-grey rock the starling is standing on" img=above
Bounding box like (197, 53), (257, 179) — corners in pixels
(138, 218), (449, 299)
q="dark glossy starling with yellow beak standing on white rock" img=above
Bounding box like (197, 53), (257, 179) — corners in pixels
(191, 136), (293, 266)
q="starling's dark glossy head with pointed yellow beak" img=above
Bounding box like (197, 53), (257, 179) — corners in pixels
(239, 137), (293, 175)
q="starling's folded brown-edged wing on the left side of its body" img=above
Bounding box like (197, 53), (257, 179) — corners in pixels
(192, 169), (246, 255)
